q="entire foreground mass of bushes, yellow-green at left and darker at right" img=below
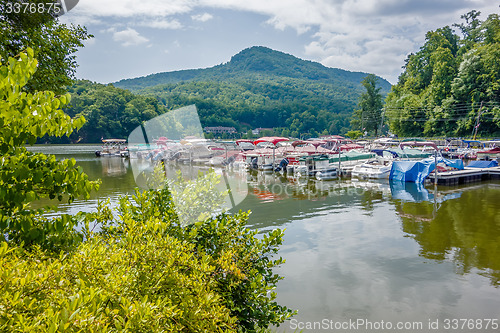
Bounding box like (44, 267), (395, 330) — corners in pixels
(0, 185), (293, 332)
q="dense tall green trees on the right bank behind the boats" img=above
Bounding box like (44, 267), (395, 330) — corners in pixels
(385, 11), (500, 137)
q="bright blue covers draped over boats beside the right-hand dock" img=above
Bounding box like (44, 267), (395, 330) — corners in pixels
(389, 157), (464, 183)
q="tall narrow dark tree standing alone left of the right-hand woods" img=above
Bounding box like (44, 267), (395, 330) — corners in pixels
(353, 74), (383, 136)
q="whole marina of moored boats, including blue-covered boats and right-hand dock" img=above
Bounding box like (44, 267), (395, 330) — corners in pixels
(122, 136), (500, 186)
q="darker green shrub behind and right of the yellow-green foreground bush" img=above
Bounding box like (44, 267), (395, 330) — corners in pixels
(109, 187), (293, 330)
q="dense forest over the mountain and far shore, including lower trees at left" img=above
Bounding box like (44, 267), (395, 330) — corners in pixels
(54, 47), (390, 142)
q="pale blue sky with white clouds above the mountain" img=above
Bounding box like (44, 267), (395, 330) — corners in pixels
(61, 0), (500, 83)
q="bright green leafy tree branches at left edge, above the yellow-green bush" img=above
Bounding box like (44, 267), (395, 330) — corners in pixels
(0, 49), (98, 249)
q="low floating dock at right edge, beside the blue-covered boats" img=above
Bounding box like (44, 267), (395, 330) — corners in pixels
(427, 167), (500, 185)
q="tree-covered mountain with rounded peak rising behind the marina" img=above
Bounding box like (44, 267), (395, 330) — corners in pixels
(114, 46), (391, 137)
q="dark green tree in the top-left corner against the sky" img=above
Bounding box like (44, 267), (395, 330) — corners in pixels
(0, 0), (93, 94)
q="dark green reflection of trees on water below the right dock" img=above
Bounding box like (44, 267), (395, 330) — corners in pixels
(394, 183), (500, 286)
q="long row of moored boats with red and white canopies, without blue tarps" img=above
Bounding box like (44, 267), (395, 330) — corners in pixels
(96, 136), (500, 180)
